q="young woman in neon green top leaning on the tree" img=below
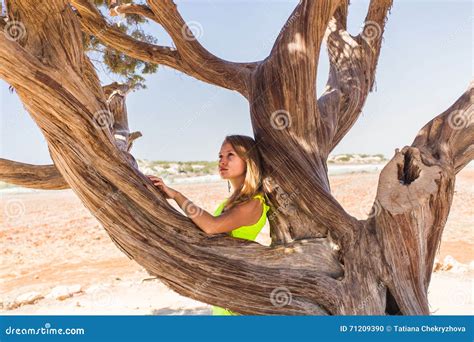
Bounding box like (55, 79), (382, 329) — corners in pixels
(148, 135), (269, 315)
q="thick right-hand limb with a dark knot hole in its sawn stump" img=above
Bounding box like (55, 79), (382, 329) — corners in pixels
(369, 83), (474, 314)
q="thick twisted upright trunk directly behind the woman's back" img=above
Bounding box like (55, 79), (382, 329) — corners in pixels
(249, 1), (362, 245)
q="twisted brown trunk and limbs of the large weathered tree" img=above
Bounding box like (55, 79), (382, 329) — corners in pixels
(0, 0), (474, 315)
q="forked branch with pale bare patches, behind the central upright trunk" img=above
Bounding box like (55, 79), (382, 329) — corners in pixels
(316, 0), (392, 156)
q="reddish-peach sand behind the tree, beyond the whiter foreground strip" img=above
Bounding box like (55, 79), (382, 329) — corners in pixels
(0, 169), (474, 313)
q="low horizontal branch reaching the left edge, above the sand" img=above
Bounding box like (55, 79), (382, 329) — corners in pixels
(0, 158), (69, 190)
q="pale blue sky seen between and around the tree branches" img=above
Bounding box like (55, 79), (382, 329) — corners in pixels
(0, 0), (473, 164)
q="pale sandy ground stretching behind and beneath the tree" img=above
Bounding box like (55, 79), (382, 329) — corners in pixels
(0, 168), (474, 315)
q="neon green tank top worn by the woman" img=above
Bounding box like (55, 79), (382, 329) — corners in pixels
(212, 194), (270, 316)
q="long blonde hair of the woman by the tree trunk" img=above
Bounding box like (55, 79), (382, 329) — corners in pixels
(222, 135), (263, 210)
